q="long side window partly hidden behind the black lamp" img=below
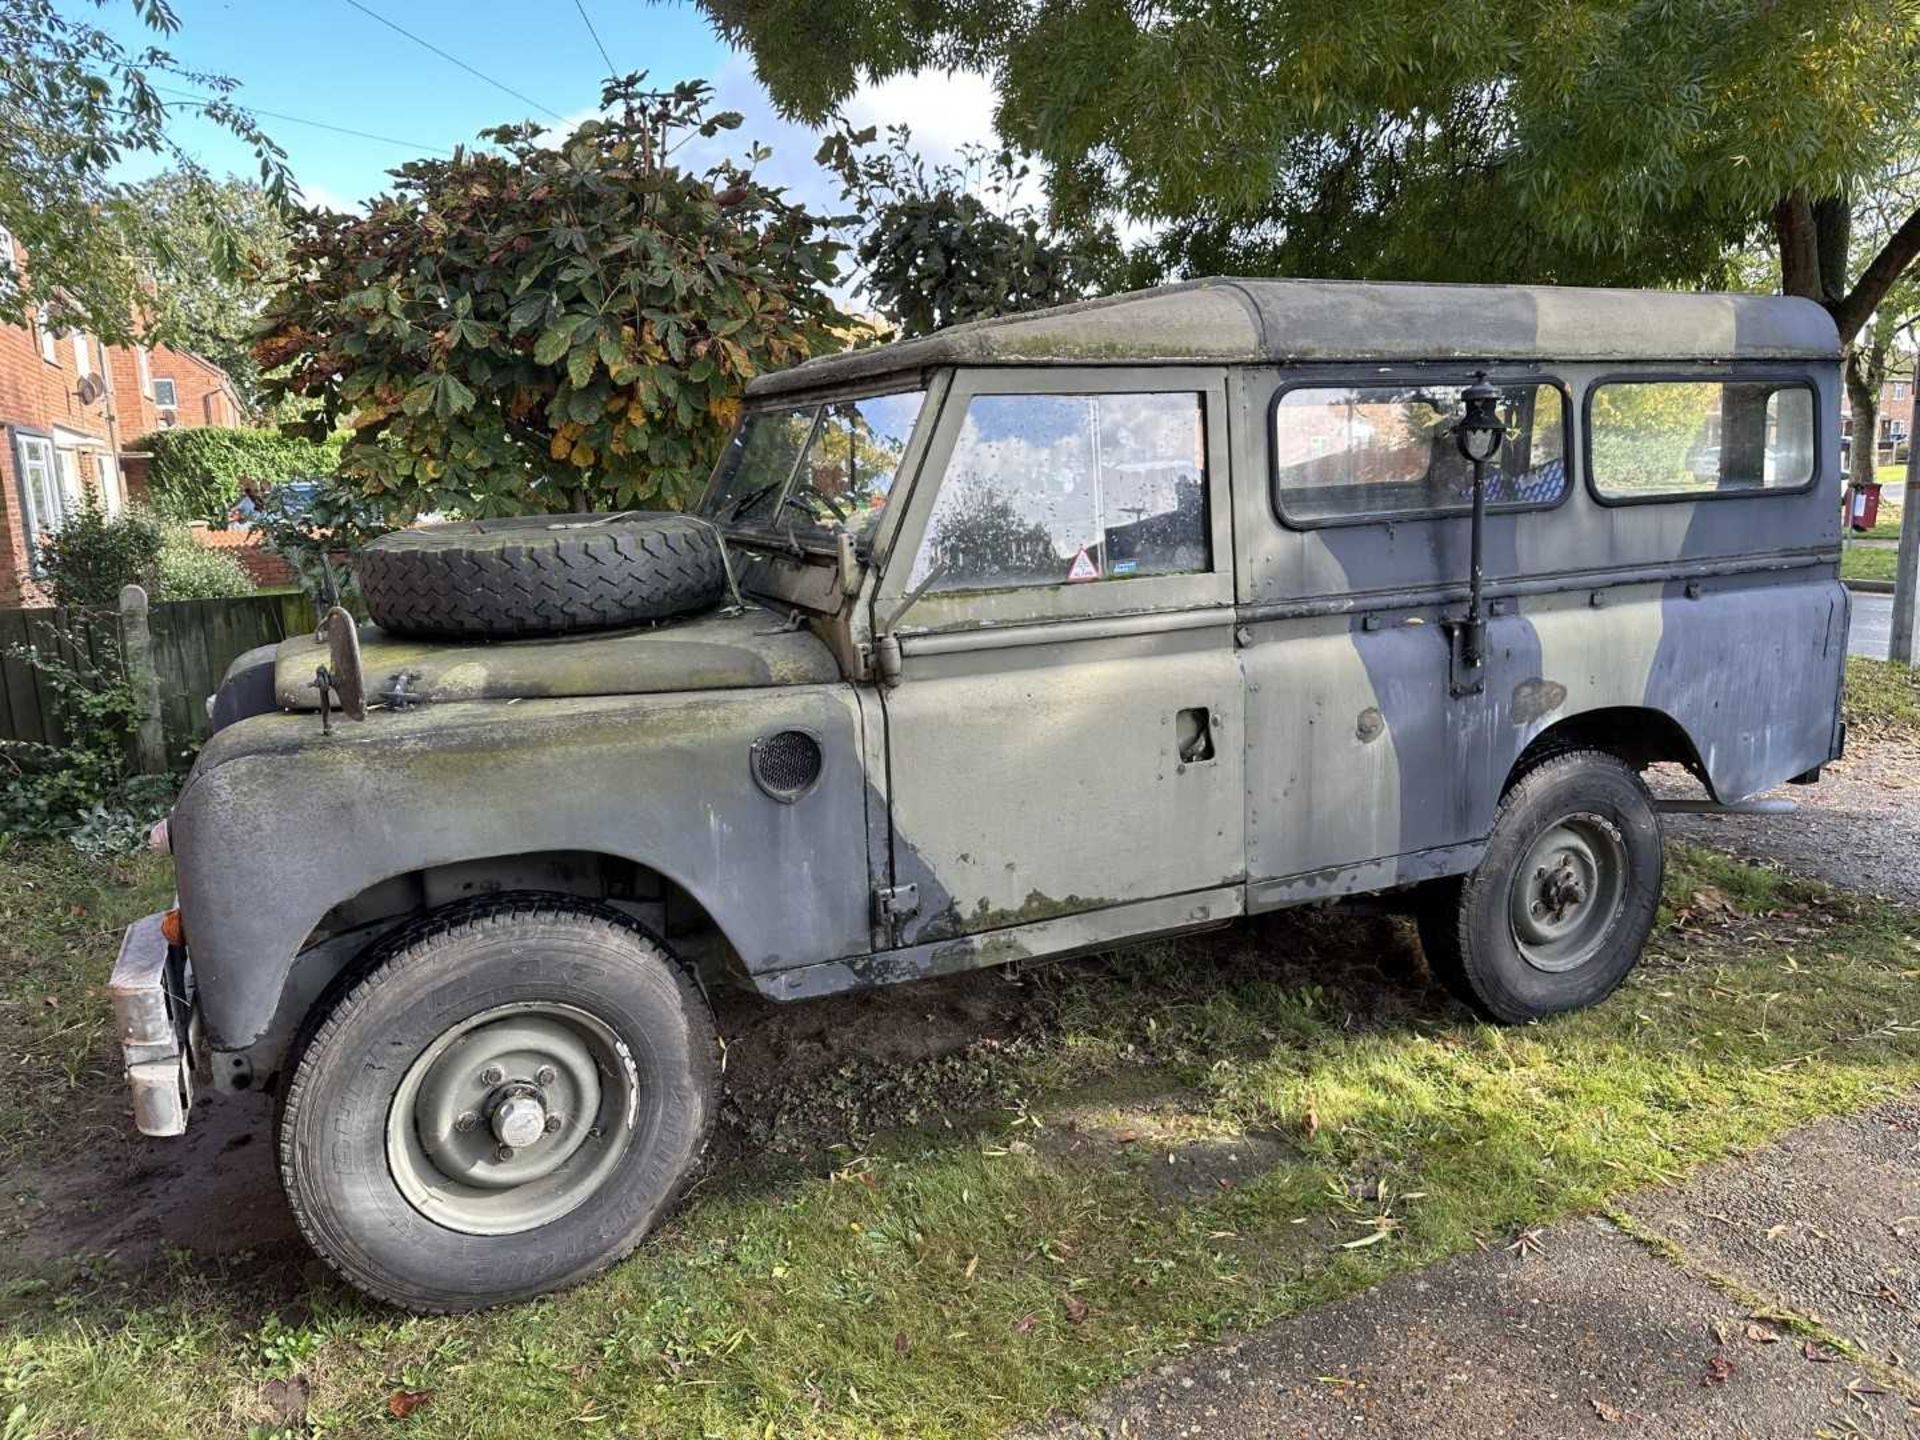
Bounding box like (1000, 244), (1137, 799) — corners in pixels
(1273, 384), (1567, 524)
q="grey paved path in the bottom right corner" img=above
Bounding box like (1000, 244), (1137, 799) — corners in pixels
(1039, 1098), (1920, 1440)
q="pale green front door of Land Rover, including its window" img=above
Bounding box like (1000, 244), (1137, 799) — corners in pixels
(874, 367), (1244, 945)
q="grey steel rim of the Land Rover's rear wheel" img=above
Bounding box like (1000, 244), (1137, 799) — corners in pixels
(1507, 814), (1626, 975)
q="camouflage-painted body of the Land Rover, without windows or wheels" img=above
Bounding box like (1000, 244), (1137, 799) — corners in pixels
(173, 282), (1847, 1071)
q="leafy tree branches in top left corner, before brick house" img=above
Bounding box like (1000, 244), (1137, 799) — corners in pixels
(0, 0), (292, 344)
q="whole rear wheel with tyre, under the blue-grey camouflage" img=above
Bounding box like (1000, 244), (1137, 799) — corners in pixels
(1419, 751), (1665, 1023)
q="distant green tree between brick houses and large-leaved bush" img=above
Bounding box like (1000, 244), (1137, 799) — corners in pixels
(127, 171), (288, 411)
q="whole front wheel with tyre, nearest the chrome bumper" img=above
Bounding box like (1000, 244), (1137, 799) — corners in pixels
(276, 897), (718, 1311)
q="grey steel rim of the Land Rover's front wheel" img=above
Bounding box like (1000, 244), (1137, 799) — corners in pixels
(386, 1000), (639, 1235)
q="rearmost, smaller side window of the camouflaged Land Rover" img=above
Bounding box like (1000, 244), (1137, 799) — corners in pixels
(1588, 380), (1814, 499)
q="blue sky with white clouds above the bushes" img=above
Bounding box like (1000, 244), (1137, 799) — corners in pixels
(97, 0), (993, 219)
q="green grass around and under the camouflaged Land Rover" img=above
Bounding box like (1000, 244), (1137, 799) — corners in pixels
(0, 683), (1920, 1440)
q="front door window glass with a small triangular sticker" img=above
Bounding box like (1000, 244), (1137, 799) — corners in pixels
(908, 392), (1213, 591)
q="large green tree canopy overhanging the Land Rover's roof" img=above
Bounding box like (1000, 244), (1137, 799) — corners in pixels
(701, 0), (1920, 336)
